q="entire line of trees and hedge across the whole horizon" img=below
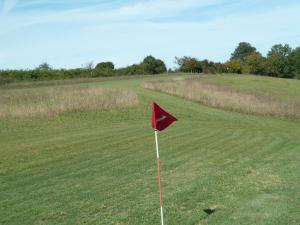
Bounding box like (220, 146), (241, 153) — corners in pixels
(0, 42), (300, 83)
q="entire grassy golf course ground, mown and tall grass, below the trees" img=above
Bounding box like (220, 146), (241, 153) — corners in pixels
(0, 73), (300, 225)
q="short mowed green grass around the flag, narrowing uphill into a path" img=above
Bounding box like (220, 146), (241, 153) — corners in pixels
(0, 76), (300, 225)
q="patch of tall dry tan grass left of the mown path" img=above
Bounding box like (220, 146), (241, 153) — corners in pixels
(0, 87), (138, 118)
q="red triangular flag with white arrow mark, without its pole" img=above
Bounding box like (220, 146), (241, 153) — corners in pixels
(152, 102), (177, 131)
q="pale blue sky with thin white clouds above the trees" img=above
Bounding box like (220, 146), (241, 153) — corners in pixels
(0, 0), (300, 69)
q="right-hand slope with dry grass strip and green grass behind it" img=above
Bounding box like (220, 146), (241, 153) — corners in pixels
(142, 75), (300, 118)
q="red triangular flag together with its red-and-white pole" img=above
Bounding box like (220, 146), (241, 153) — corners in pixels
(152, 102), (177, 225)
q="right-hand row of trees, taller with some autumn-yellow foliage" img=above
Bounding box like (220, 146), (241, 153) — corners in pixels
(175, 42), (300, 79)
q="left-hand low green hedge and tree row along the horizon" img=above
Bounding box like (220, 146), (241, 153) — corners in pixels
(0, 55), (167, 84)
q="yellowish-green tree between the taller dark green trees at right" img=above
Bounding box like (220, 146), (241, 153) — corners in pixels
(246, 52), (267, 75)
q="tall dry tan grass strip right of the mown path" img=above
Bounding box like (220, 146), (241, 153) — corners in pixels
(142, 79), (300, 117)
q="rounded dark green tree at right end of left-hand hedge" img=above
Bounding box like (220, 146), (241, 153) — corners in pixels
(142, 55), (167, 74)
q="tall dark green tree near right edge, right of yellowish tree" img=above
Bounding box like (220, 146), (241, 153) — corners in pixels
(267, 44), (293, 78)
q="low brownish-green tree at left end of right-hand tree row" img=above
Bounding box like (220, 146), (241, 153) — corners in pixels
(175, 56), (202, 73)
